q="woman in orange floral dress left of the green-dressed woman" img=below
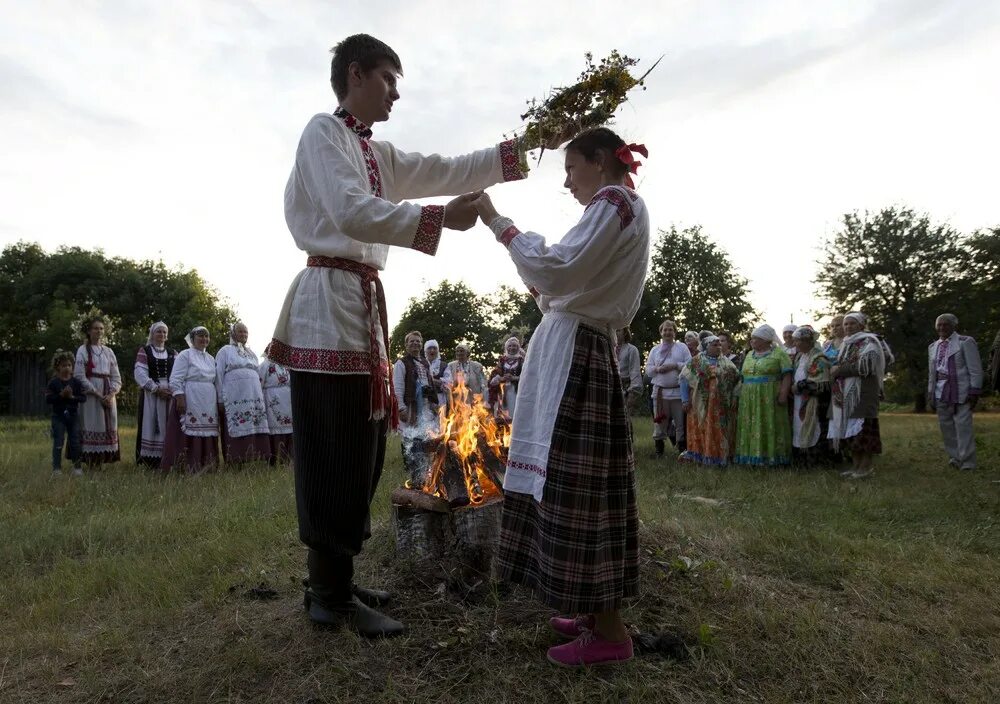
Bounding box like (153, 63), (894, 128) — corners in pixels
(680, 335), (740, 465)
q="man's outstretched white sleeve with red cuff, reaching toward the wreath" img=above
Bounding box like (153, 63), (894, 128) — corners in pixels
(372, 140), (525, 198)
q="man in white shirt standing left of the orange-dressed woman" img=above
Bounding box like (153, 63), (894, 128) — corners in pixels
(646, 320), (698, 458)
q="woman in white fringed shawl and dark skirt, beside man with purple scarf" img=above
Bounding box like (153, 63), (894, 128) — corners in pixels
(829, 312), (885, 479)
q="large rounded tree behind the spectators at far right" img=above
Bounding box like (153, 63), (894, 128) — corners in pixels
(816, 207), (983, 412)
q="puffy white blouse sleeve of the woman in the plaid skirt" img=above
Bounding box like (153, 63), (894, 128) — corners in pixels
(494, 187), (635, 296)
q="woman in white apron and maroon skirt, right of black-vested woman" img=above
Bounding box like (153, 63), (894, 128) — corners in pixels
(160, 325), (219, 472)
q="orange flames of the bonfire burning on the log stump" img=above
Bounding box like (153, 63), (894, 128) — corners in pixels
(423, 373), (510, 506)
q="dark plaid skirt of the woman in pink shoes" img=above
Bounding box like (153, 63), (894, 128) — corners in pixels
(497, 324), (639, 613)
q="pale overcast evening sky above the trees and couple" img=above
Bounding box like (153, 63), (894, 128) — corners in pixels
(0, 0), (1000, 353)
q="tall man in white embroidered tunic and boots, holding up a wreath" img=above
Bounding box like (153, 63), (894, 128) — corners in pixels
(268, 34), (527, 637)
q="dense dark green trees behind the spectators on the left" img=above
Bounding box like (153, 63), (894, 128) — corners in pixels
(0, 242), (236, 396)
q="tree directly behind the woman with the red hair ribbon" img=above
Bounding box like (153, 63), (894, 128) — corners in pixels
(632, 225), (758, 346)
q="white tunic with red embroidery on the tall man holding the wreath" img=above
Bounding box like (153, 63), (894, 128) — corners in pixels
(267, 108), (524, 402)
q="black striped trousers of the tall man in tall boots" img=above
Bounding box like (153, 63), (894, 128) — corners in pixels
(291, 371), (388, 556)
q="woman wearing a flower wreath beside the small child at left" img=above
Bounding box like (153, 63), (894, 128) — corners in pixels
(73, 316), (122, 466)
